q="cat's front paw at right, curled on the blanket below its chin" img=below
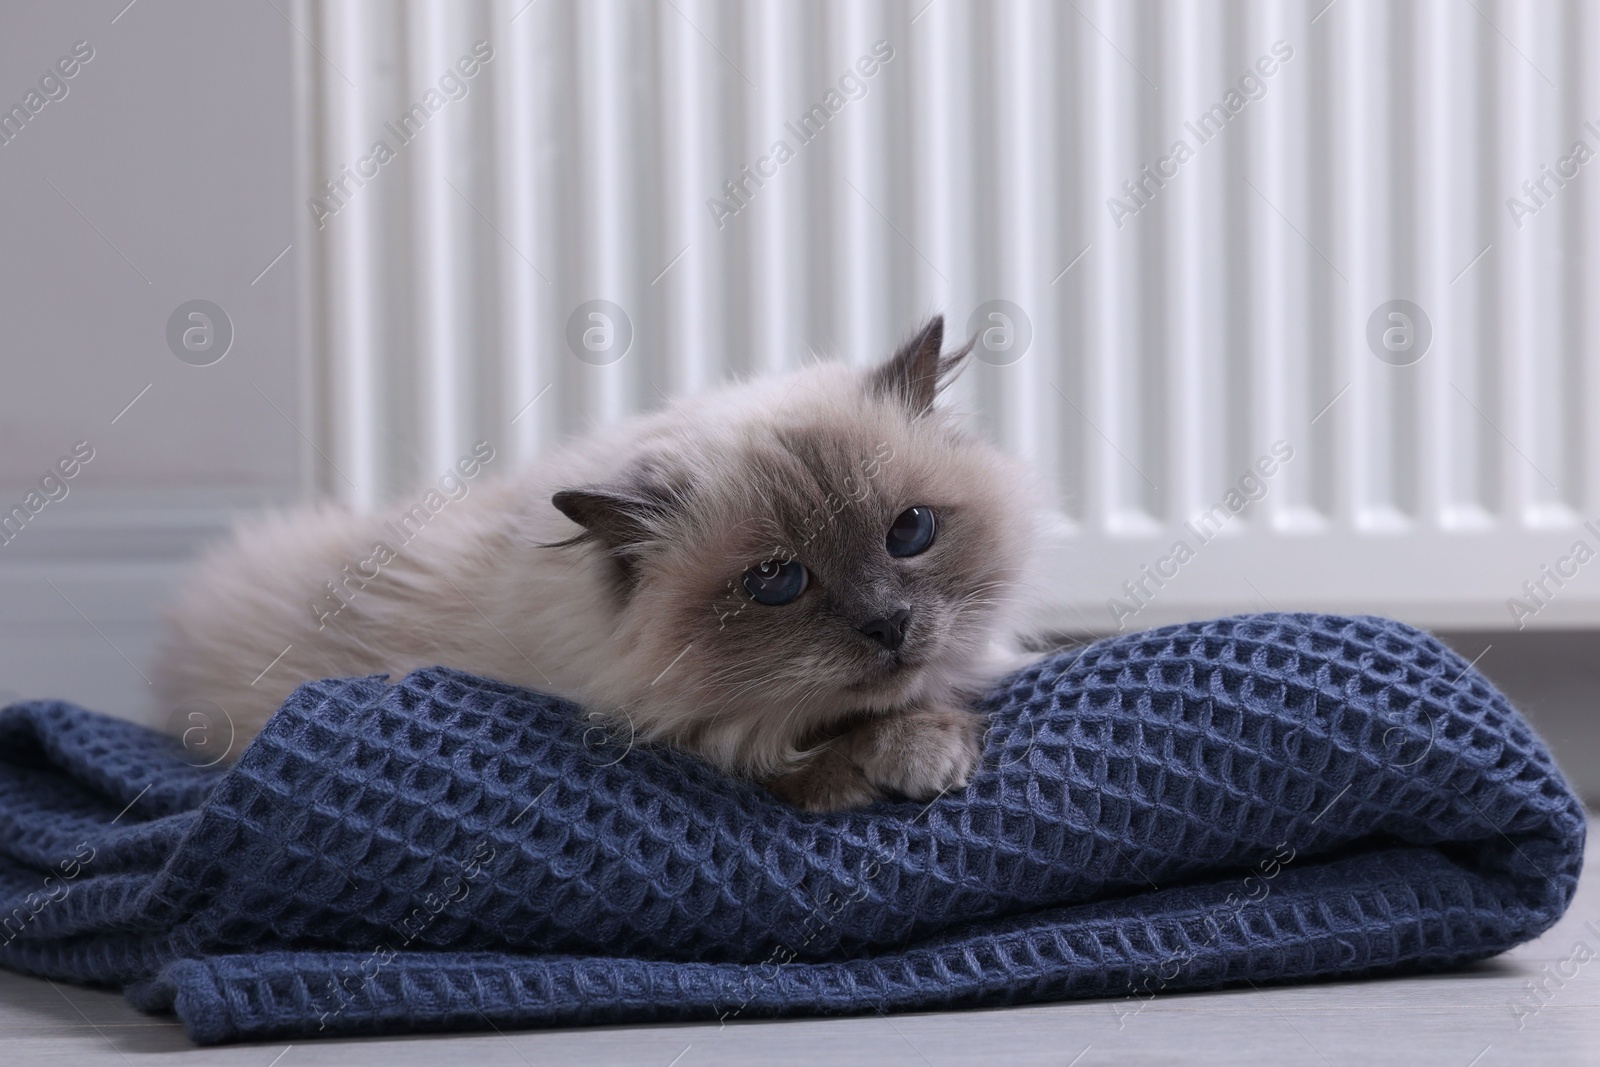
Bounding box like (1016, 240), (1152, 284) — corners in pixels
(848, 707), (982, 800)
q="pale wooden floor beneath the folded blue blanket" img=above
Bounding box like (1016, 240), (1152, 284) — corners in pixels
(0, 819), (1600, 1067)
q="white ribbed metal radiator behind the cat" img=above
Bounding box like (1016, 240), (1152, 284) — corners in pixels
(288, 0), (1600, 630)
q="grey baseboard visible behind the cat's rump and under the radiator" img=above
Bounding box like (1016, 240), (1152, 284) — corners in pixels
(0, 490), (1600, 805)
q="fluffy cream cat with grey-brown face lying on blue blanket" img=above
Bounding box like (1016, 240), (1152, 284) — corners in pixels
(155, 317), (1042, 811)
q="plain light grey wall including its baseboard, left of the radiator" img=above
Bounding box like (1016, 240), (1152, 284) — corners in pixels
(0, 0), (301, 713)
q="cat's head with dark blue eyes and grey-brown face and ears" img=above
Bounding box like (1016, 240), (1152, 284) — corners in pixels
(554, 318), (1038, 773)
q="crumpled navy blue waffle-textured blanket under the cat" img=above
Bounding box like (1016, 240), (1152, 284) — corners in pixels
(0, 614), (1584, 1043)
